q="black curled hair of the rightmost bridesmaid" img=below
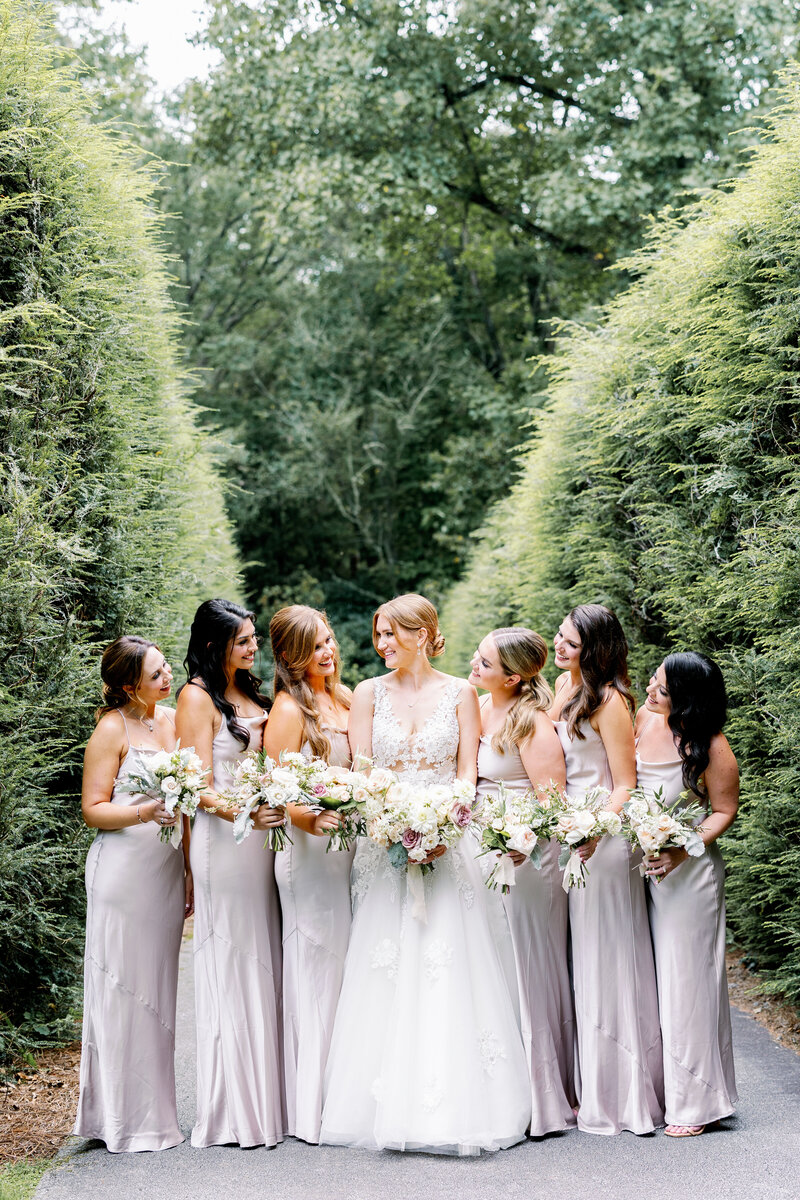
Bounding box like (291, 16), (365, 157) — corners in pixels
(663, 650), (728, 799)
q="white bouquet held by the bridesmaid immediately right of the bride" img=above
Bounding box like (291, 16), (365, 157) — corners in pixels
(479, 784), (558, 894)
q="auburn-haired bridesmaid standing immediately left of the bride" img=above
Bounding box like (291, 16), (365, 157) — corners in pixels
(264, 605), (355, 1142)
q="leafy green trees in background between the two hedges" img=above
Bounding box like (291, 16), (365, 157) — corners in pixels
(161, 0), (796, 678)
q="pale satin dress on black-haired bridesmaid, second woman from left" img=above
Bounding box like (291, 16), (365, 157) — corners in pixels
(191, 713), (284, 1146)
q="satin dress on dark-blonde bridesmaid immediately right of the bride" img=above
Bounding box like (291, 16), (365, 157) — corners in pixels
(477, 734), (576, 1138)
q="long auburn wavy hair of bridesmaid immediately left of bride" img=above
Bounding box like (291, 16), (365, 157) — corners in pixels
(270, 604), (350, 758)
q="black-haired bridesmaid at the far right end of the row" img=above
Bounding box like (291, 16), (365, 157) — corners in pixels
(636, 652), (739, 1138)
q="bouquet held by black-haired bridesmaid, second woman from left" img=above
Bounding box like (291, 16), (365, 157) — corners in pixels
(221, 750), (308, 851)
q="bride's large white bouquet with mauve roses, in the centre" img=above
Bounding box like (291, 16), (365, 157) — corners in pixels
(366, 770), (475, 871)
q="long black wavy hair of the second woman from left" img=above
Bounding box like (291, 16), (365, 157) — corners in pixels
(181, 600), (270, 750)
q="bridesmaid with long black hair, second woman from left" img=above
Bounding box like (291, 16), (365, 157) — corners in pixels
(178, 600), (283, 1146)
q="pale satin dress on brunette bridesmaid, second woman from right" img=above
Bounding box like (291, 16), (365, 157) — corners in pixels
(555, 721), (663, 1134)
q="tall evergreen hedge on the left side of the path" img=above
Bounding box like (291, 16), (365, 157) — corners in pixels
(0, 0), (237, 1054)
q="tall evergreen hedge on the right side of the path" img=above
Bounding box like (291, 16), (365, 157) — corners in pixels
(443, 70), (800, 1001)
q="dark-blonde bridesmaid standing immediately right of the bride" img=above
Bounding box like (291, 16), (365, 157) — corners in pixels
(469, 628), (575, 1138)
